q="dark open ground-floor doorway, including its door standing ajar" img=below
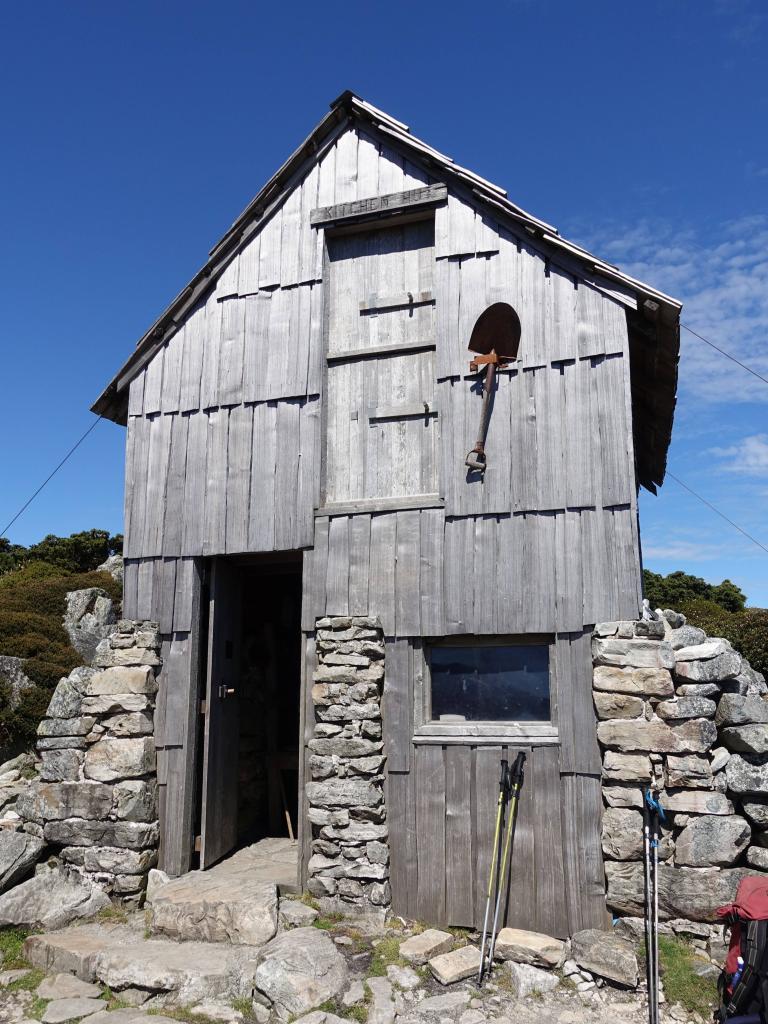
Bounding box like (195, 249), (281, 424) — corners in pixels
(196, 554), (301, 881)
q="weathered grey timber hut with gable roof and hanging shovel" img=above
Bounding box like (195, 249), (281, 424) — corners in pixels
(93, 92), (680, 935)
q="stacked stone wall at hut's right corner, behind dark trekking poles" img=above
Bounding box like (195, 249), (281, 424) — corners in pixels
(593, 608), (768, 931)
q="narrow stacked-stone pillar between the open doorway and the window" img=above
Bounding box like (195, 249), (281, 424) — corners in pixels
(306, 616), (391, 913)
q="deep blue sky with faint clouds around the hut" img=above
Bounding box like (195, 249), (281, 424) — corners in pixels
(0, 0), (768, 606)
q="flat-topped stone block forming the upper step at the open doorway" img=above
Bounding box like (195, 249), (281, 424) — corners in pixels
(150, 848), (278, 946)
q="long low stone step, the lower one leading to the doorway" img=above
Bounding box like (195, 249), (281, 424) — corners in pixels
(25, 918), (258, 1006)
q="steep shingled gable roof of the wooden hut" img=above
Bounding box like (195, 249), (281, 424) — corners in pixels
(92, 91), (681, 493)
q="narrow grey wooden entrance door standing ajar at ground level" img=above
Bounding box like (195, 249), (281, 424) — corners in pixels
(200, 558), (242, 867)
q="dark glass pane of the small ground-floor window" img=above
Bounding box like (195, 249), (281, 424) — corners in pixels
(429, 644), (550, 724)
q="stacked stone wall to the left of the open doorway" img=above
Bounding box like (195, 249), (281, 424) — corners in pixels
(16, 620), (161, 902)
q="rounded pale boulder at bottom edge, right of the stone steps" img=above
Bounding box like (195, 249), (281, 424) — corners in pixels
(254, 928), (347, 1020)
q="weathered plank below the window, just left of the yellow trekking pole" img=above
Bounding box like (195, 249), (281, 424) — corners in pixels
(445, 745), (475, 928)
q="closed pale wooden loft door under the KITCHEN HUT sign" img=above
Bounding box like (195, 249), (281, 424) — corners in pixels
(326, 220), (437, 504)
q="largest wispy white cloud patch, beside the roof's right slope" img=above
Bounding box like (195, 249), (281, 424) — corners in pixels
(587, 214), (768, 404)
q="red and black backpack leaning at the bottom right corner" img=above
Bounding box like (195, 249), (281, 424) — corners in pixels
(715, 874), (768, 1021)
